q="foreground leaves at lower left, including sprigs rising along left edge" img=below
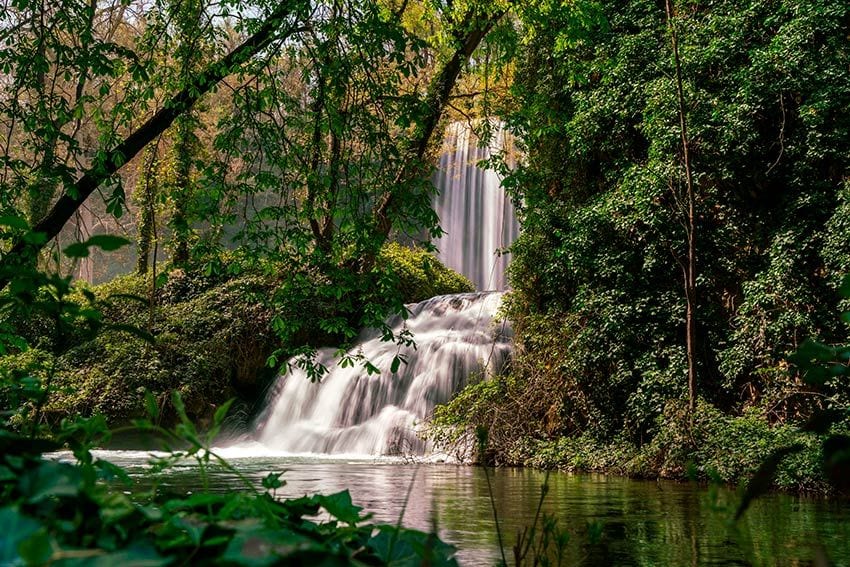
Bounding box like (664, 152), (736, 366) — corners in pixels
(0, 226), (456, 565)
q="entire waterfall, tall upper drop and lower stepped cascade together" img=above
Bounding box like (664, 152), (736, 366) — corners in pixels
(247, 121), (519, 455)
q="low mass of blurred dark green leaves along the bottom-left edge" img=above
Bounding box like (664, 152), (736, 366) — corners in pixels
(0, 424), (456, 566)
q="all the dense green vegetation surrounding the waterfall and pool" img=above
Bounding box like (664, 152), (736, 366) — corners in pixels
(0, 0), (850, 564)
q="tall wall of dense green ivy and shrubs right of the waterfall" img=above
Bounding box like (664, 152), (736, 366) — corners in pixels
(434, 1), (850, 487)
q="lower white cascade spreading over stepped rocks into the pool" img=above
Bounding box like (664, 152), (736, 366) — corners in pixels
(256, 293), (511, 455)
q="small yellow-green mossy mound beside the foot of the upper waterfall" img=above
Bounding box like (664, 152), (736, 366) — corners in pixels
(379, 243), (475, 303)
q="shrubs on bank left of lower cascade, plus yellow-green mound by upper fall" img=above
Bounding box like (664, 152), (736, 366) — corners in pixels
(0, 244), (472, 426)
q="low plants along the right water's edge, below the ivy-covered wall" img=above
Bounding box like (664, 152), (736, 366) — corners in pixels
(429, 392), (846, 495)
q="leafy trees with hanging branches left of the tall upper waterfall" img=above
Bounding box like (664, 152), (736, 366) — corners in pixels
(0, 0), (505, 355)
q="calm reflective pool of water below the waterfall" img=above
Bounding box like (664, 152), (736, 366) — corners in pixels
(83, 451), (850, 566)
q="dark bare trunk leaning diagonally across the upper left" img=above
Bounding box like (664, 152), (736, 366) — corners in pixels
(0, 0), (302, 289)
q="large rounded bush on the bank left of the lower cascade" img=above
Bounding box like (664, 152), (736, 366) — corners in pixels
(2, 271), (276, 426)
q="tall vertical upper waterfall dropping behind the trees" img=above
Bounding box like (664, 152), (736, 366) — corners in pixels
(434, 121), (519, 290)
